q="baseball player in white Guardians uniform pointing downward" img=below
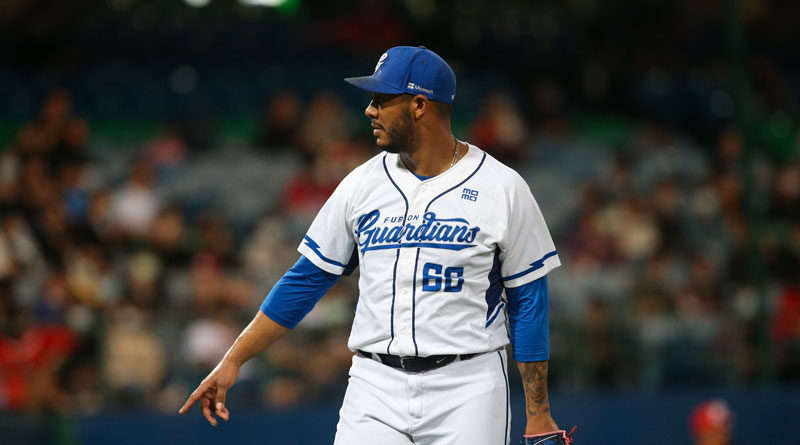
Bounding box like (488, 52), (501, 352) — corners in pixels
(180, 46), (571, 445)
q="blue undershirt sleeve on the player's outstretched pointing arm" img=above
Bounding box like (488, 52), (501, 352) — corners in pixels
(261, 255), (339, 329)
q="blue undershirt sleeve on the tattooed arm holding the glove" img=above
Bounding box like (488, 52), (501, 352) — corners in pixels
(506, 275), (550, 362)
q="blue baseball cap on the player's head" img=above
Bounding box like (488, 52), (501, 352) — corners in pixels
(345, 46), (456, 104)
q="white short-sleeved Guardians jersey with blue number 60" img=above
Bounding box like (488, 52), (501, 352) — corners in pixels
(298, 145), (560, 357)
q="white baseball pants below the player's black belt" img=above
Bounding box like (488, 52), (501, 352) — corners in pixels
(334, 350), (511, 445)
